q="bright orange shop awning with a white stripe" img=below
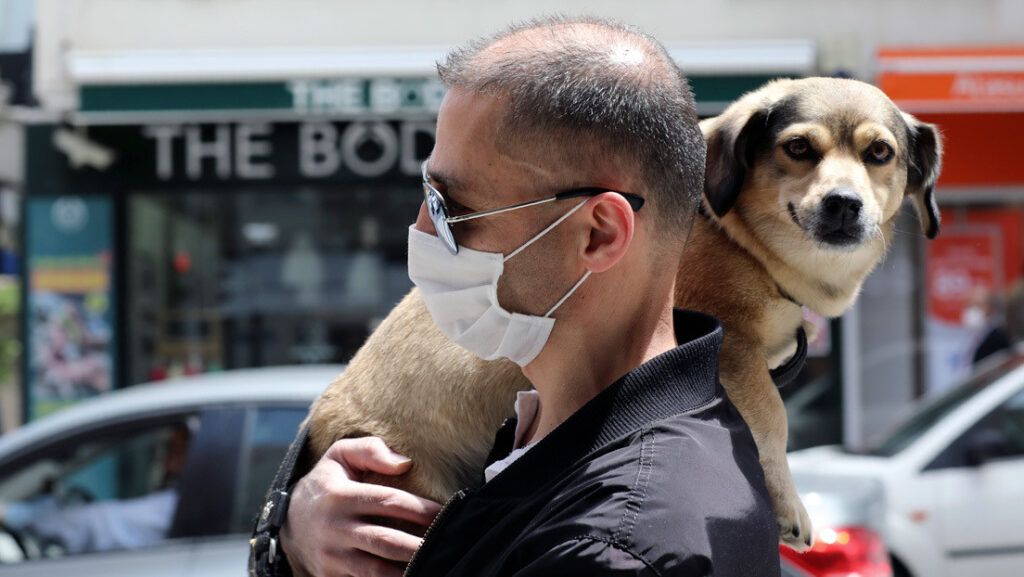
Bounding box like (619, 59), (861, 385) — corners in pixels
(878, 46), (1024, 113)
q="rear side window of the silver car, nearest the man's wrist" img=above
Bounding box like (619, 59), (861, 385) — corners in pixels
(231, 407), (307, 533)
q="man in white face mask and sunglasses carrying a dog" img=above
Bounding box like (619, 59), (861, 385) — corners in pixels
(272, 18), (779, 577)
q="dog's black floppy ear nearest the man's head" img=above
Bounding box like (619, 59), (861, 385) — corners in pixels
(705, 109), (769, 218)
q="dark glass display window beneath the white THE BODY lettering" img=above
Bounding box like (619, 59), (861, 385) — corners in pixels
(126, 180), (421, 383)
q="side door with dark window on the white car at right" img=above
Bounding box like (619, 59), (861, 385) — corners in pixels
(922, 390), (1024, 577)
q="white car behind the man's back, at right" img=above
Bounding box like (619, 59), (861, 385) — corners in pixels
(790, 349), (1024, 577)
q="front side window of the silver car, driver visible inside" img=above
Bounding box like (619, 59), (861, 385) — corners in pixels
(0, 417), (198, 562)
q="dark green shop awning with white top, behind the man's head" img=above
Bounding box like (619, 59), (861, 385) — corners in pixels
(67, 40), (817, 124)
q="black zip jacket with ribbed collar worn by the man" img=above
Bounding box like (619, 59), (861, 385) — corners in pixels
(407, 311), (779, 577)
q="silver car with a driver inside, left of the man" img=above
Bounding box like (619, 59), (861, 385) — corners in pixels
(0, 366), (343, 577)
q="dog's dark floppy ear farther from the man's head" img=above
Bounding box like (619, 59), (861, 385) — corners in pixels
(903, 113), (942, 239)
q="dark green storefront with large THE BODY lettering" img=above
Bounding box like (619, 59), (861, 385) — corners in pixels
(24, 42), (815, 418)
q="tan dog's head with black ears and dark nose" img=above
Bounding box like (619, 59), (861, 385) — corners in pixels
(701, 78), (941, 252)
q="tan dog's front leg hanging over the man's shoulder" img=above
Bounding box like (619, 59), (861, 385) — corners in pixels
(722, 335), (813, 550)
